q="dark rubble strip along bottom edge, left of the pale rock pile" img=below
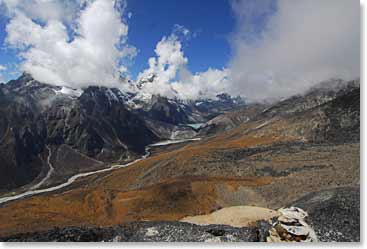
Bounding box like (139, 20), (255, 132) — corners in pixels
(0, 221), (270, 242)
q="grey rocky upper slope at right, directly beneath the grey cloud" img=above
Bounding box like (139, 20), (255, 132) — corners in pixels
(199, 80), (360, 139)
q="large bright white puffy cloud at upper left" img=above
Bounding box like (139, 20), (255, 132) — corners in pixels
(5, 0), (137, 88)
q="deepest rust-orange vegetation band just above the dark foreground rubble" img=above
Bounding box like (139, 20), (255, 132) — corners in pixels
(0, 177), (271, 235)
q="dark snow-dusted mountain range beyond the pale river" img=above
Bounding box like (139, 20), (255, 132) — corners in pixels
(0, 73), (245, 190)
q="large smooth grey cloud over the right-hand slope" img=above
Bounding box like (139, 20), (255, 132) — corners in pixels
(228, 0), (360, 100)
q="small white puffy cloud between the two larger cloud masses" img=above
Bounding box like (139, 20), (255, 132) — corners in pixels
(137, 25), (228, 99)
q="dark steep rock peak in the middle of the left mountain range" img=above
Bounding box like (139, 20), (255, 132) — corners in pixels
(47, 87), (158, 161)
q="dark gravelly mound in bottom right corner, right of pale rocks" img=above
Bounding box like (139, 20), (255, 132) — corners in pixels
(291, 187), (360, 242)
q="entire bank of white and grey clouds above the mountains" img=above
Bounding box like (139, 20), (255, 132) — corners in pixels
(0, 0), (360, 100)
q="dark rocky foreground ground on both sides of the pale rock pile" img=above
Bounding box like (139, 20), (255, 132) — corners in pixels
(0, 188), (360, 242)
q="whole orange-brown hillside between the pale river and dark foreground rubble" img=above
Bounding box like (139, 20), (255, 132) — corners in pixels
(0, 113), (359, 236)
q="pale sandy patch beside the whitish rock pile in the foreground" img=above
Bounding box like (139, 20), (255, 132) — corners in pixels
(181, 206), (281, 227)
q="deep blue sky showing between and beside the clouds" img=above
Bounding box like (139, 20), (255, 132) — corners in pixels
(0, 0), (236, 80)
